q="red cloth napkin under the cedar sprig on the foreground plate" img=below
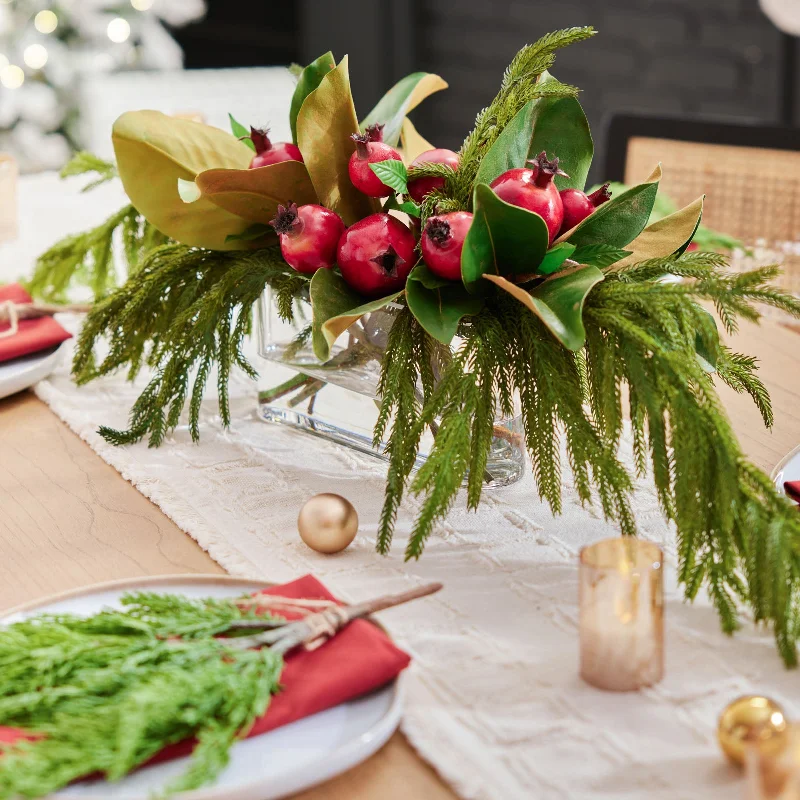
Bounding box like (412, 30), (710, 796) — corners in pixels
(0, 575), (411, 763)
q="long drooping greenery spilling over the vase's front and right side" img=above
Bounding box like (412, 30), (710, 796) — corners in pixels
(378, 253), (800, 665)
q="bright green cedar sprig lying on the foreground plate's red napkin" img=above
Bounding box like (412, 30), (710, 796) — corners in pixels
(0, 593), (283, 800)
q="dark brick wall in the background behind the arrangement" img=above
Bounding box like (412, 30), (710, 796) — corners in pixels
(414, 0), (786, 179)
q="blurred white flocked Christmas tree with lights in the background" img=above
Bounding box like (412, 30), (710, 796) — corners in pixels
(0, 0), (205, 171)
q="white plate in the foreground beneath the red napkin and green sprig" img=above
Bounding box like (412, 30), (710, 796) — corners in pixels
(0, 575), (402, 800)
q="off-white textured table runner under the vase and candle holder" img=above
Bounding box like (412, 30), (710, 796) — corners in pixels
(0, 177), (800, 800)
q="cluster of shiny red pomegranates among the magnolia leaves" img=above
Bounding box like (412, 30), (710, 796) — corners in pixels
(270, 136), (611, 297)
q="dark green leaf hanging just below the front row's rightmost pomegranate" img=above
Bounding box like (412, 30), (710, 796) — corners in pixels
(406, 264), (483, 344)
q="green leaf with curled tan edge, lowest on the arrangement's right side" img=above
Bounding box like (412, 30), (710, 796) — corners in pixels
(483, 266), (603, 351)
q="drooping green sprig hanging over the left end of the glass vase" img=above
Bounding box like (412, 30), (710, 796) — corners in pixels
(73, 245), (308, 446)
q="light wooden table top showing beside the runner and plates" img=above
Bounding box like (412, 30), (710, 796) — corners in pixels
(0, 314), (800, 800)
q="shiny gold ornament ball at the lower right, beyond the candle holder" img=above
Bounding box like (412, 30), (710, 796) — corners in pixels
(717, 695), (789, 764)
